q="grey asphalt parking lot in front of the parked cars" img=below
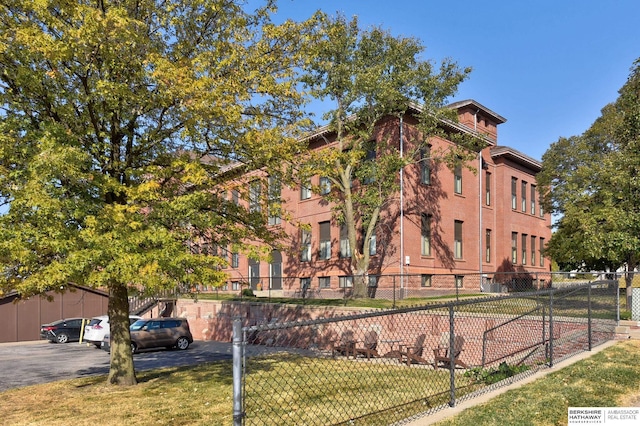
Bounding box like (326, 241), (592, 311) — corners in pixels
(0, 340), (232, 392)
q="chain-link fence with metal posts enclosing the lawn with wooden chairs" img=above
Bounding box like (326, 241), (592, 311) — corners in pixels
(233, 280), (619, 426)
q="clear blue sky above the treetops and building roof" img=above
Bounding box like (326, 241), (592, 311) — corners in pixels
(277, 0), (640, 160)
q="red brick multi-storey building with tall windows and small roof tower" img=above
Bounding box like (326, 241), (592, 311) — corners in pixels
(214, 100), (551, 297)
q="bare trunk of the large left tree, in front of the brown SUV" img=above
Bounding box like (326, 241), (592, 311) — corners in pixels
(108, 283), (138, 386)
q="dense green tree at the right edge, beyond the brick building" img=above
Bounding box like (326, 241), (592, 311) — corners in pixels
(538, 57), (640, 271)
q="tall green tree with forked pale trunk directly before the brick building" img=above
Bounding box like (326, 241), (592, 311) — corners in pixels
(306, 16), (475, 298)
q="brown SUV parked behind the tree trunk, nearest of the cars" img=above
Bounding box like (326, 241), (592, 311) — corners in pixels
(102, 318), (193, 353)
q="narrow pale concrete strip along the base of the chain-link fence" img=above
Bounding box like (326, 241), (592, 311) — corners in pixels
(403, 321), (640, 426)
